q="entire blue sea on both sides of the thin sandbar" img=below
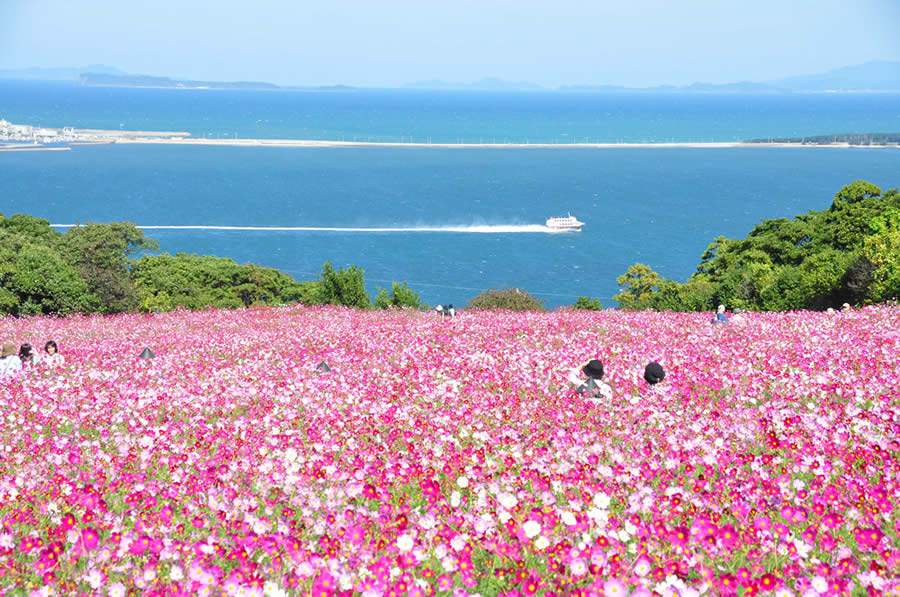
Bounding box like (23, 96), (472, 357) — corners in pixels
(0, 81), (900, 307)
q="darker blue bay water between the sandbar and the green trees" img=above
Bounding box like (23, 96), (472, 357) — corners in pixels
(0, 145), (900, 307)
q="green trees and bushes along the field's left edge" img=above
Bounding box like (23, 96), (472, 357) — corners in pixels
(0, 214), (372, 315)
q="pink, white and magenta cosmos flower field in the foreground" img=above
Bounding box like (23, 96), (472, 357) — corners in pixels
(0, 306), (900, 597)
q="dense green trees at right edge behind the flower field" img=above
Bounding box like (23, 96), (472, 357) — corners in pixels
(616, 180), (900, 311)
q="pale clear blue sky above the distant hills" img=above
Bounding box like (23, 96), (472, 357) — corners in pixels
(0, 0), (900, 88)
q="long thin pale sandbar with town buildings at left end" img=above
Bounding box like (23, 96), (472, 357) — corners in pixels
(0, 120), (900, 151)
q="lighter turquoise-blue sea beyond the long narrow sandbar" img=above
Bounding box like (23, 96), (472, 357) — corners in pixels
(0, 80), (900, 144)
